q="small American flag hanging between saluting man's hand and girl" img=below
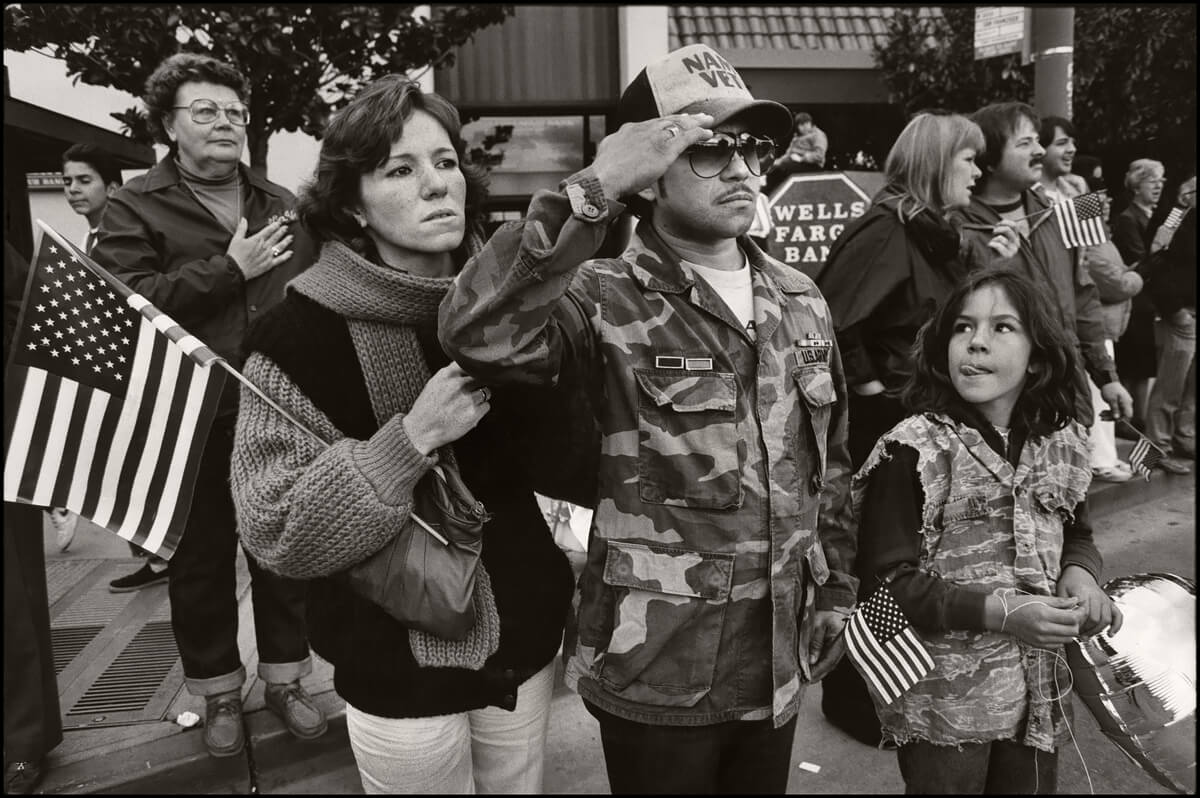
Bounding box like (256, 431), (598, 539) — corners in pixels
(846, 584), (934, 703)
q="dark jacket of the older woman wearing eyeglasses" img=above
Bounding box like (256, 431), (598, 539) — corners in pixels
(92, 156), (316, 414)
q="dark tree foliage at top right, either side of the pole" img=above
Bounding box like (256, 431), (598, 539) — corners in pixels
(875, 4), (1196, 185)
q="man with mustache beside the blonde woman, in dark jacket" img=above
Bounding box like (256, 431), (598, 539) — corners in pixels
(958, 102), (1133, 427)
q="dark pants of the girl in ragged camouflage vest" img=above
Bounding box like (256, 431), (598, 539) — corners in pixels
(896, 740), (1058, 796)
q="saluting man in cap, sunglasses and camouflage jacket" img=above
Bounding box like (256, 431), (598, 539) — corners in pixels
(439, 44), (856, 793)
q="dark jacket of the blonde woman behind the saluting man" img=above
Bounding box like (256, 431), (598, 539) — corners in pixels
(817, 197), (966, 395)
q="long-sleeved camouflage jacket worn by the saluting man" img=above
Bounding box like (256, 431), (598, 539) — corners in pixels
(439, 169), (857, 725)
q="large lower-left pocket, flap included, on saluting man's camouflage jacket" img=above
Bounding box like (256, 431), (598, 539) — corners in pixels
(598, 541), (733, 707)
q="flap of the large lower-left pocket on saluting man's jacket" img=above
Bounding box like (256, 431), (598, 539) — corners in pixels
(604, 540), (733, 600)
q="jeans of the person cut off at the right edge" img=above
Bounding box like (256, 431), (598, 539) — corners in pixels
(1146, 307), (1196, 456)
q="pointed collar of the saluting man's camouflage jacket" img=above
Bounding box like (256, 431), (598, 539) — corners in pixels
(622, 218), (817, 294)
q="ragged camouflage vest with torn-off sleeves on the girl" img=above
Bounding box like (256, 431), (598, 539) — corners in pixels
(851, 414), (1092, 751)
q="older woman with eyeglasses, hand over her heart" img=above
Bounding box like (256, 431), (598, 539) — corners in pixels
(92, 53), (325, 756)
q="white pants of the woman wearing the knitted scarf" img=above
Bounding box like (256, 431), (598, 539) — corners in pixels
(346, 660), (554, 794)
